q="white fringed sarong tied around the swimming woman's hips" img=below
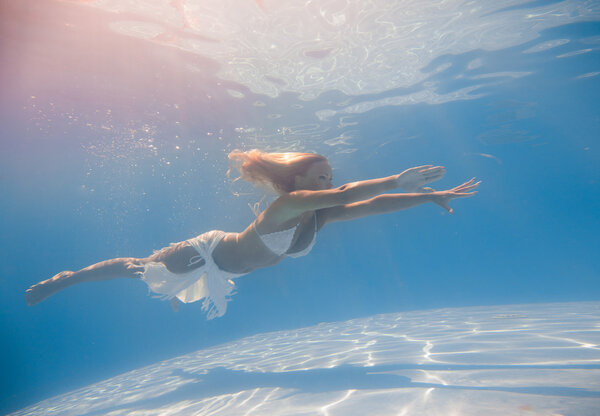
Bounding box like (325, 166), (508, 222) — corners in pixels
(140, 230), (244, 319)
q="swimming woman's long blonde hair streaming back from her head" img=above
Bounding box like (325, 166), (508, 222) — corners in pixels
(228, 149), (327, 194)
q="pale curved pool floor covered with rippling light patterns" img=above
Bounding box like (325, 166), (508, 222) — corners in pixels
(14, 302), (600, 416)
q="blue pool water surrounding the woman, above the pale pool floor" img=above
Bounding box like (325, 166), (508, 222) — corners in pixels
(0, 0), (600, 413)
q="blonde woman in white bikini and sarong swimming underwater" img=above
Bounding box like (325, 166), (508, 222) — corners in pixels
(25, 150), (480, 319)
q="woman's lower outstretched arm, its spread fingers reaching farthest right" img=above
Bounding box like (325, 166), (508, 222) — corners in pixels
(321, 179), (481, 224)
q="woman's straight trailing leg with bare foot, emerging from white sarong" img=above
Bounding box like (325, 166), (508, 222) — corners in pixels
(25, 241), (205, 306)
